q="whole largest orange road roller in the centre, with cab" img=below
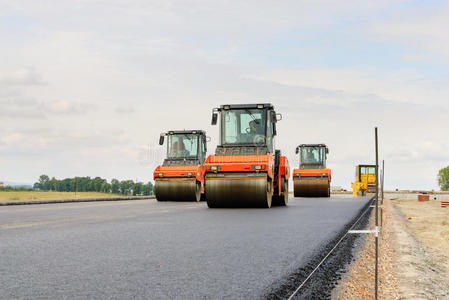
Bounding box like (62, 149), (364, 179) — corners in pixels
(204, 103), (290, 208)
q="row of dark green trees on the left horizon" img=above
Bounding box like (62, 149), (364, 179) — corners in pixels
(33, 175), (153, 196)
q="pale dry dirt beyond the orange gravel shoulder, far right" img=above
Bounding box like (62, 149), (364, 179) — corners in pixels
(392, 200), (449, 299)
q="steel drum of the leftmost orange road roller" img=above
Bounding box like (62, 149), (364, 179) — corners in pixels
(154, 178), (201, 201)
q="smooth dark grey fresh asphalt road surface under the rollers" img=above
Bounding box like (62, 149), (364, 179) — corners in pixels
(0, 196), (368, 299)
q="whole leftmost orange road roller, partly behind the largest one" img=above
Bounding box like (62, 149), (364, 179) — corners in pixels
(154, 130), (207, 201)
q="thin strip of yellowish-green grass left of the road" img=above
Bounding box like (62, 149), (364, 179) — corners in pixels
(0, 191), (122, 201)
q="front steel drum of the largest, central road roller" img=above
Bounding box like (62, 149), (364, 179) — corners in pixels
(206, 173), (272, 208)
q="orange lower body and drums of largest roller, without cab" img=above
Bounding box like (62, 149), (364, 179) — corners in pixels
(204, 152), (290, 208)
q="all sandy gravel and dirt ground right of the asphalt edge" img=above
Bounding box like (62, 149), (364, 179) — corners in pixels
(332, 199), (449, 299)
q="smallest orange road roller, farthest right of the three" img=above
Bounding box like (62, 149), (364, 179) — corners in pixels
(293, 144), (331, 197)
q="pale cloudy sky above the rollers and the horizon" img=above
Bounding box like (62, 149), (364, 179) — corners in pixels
(0, 0), (449, 190)
